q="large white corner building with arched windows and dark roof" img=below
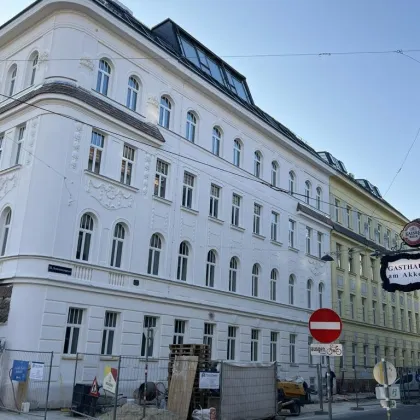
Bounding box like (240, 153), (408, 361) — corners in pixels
(0, 0), (332, 406)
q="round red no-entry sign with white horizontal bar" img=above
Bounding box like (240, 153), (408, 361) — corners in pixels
(309, 308), (343, 344)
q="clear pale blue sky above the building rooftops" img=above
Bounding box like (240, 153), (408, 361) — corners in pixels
(0, 0), (420, 219)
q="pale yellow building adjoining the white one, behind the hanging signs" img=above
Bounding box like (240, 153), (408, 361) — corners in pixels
(327, 171), (420, 379)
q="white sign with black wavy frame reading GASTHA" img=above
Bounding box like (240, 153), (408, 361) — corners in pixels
(381, 252), (420, 292)
